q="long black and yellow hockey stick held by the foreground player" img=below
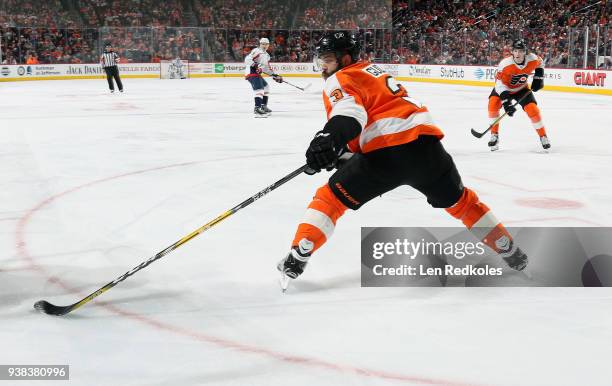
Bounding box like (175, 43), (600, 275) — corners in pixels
(34, 165), (307, 316)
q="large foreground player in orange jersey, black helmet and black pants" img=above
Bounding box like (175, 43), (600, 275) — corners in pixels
(277, 32), (527, 282)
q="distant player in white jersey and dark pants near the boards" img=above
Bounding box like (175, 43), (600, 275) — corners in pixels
(244, 38), (283, 118)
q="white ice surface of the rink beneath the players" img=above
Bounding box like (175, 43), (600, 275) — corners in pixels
(0, 78), (612, 386)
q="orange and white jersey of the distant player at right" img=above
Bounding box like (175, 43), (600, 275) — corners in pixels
(495, 53), (544, 94)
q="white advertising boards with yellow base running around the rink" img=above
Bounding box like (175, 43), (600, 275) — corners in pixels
(0, 63), (612, 95)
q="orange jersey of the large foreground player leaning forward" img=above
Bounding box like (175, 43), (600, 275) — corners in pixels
(323, 62), (444, 153)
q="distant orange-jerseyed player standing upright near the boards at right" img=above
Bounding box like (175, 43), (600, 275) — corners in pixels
(489, 39), (550, 151)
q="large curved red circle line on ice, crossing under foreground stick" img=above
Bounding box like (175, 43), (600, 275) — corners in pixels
(15, 157), (468, 386)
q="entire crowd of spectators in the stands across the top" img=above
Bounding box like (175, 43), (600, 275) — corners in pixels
(0, 0), (612, 67)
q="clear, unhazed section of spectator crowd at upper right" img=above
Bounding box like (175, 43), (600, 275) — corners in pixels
(392, 0), (612, 66)
